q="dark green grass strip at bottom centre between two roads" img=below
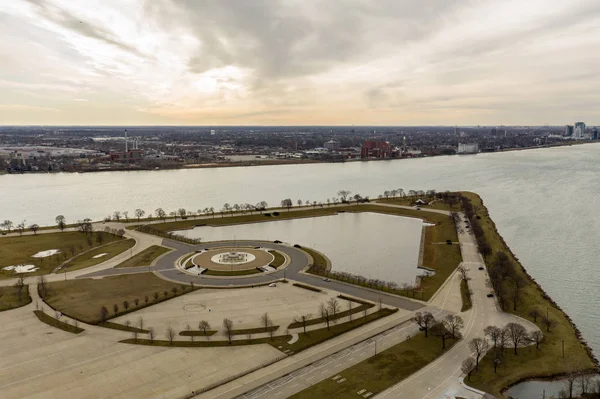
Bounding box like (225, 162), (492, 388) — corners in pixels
(290, 333), (453, 399)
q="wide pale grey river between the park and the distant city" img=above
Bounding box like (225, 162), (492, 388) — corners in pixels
(0, 144), (600, 354)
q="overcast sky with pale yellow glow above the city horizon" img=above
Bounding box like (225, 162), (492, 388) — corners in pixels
(0, 0), (600, 125)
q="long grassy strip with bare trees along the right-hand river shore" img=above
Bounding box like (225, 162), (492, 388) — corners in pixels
(462, 192), (594, 397)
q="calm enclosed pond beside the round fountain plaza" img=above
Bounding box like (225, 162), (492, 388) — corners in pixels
(177, 212), (423, 285)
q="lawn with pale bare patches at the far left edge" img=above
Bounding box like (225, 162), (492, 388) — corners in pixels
(0, 231), (120, 278)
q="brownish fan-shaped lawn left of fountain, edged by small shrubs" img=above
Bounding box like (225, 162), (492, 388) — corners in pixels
(38, 273), (191, 324)
